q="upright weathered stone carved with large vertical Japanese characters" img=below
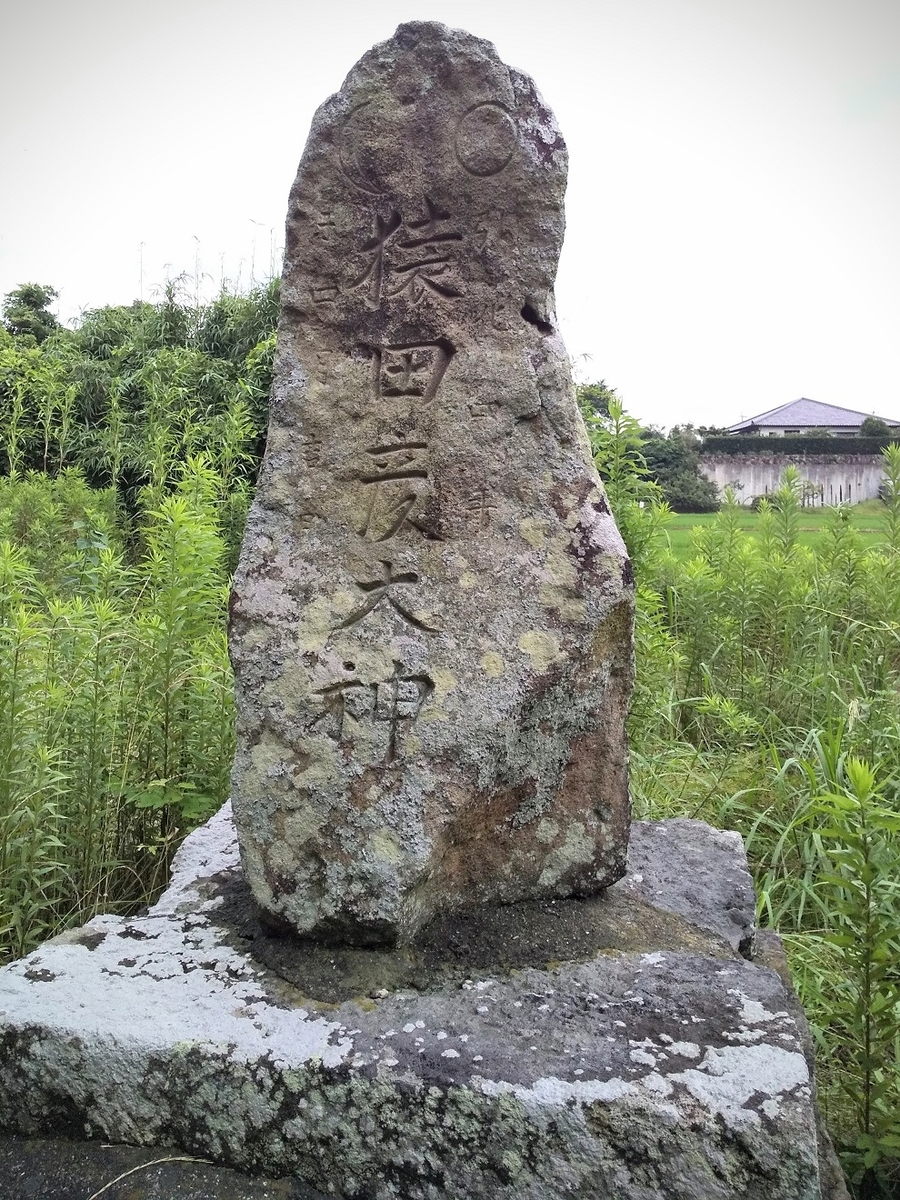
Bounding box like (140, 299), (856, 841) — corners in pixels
(230, 14), (632, 943)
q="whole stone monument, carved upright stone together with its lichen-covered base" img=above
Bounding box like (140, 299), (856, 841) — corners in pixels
(0, 24), (846, 1200)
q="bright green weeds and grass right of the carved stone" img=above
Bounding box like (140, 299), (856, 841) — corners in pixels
(590, 407), (900, 1200)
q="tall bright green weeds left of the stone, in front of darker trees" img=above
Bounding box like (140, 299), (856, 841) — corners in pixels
(0, 462), (233, 958)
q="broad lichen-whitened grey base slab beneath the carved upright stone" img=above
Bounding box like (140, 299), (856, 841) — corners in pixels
(0, 809), (841, 1200)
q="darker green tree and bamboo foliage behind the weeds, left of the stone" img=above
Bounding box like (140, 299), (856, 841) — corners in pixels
(0, 281), (278, 559)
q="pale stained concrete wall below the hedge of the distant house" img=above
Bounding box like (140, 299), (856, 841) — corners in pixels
(700, 454), (884, 505)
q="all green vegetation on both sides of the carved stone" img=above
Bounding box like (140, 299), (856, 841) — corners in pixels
(0, 284), (900, 1200)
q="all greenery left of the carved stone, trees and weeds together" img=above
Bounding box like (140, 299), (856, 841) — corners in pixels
(0, 284), (277, 961)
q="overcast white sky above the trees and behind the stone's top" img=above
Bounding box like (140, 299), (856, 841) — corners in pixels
(0, 0), (900, 426)
